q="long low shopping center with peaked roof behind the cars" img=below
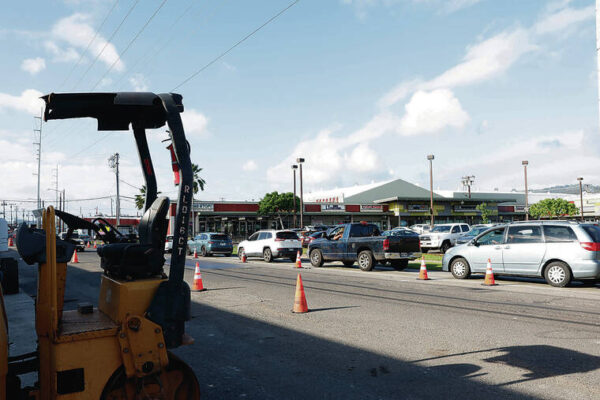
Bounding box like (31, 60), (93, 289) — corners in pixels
(169, 179), (525, 240)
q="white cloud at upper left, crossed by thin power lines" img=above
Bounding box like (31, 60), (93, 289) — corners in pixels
(51, 13), (125, 72)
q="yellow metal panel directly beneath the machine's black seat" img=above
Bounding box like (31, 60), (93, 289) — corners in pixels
(98, 275), (164, 324)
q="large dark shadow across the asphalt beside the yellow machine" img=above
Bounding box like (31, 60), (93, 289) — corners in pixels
(174, 302), (548, 400)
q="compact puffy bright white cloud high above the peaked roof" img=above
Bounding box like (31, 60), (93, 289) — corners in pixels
(400, 89), (469, 135)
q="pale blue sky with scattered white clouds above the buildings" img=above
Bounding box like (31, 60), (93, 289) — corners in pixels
(0, 0), (600, 214)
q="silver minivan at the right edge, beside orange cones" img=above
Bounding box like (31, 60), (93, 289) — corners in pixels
(442, 221), (600, 287)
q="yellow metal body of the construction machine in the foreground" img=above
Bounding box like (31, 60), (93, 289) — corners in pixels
(27, 207), (188, 400)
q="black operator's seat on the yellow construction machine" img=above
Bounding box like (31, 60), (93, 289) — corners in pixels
(97, 196), (169, 280)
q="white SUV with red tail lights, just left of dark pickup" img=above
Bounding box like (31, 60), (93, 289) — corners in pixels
(238, 230), (302, 262)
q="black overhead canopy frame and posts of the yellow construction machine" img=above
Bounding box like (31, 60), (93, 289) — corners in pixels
(42, 92), (193, 348)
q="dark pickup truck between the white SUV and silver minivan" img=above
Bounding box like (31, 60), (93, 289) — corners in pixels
(308, 222), (421, 271)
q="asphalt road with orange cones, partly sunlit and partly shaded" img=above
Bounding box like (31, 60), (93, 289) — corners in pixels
(16, 252), (600, 399)
